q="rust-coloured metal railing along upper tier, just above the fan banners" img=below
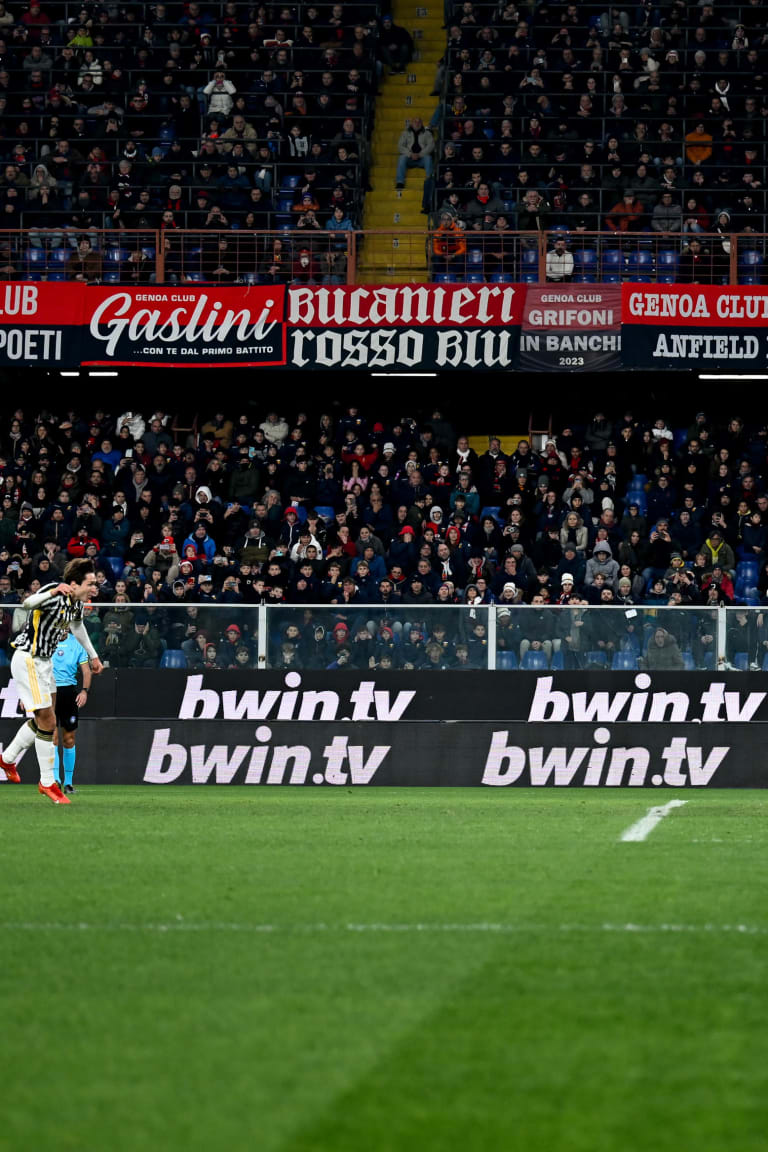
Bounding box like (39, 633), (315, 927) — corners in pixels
(0, 220), (768, 285)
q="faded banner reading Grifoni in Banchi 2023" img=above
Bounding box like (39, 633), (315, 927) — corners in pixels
(519, 283), (622, 372)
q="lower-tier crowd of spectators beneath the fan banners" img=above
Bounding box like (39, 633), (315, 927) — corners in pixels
(0, 407), (768, 667)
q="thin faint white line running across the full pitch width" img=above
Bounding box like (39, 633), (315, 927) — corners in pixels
(0, 917), (768, 935)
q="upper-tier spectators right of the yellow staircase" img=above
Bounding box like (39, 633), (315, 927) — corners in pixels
(433, 0), (768, 283)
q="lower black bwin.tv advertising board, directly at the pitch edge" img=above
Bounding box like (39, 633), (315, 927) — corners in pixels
(0, 720), (768, 788)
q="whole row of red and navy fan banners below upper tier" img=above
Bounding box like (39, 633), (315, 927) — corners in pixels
(0, 282), (768, 372)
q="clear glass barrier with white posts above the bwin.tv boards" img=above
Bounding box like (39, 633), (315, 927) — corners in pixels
(0, 601), (750, 673)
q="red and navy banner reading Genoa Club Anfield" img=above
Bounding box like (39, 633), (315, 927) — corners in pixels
(622, 285), (768, 372)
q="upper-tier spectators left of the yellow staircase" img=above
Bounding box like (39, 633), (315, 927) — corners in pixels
(0, 0), (388, 279)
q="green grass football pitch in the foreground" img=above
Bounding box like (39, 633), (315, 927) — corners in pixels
(0, 785), (768, 1152)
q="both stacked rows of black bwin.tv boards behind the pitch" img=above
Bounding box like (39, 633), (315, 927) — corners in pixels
(0, 669), (768, 788)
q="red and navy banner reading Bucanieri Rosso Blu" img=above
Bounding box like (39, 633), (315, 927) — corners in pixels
(288, 285), (525, 372)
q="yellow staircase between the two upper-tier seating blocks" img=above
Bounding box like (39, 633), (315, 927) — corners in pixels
(358, 0), (446, 283)
